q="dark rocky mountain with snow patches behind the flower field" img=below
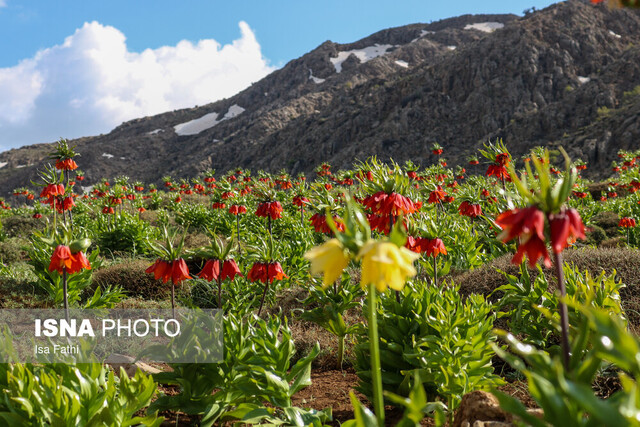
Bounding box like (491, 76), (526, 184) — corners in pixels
(0, 0), (640, 194)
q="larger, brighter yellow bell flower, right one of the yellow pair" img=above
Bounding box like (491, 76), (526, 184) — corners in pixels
(358, 241), (420, 292)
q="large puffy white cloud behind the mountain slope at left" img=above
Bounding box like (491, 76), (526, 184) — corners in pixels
(0, 22), (274, 149)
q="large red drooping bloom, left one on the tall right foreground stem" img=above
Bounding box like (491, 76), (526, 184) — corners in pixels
(496, 206), (551, 267)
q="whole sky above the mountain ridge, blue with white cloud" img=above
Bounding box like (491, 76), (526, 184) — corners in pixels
(0, 0), (554, 150)
